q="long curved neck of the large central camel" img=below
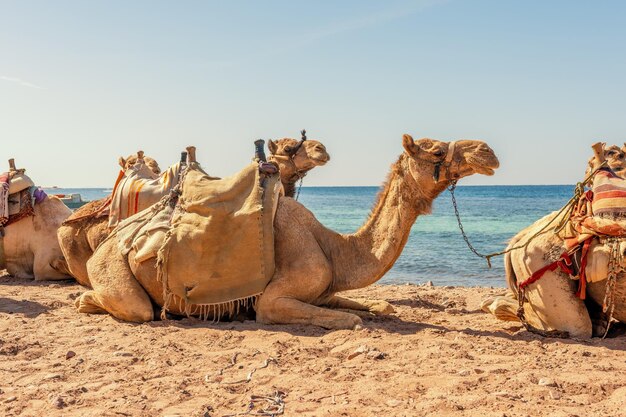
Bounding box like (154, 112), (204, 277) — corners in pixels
(332, 155), (445, 291)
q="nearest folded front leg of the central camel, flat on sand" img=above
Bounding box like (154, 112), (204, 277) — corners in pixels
(256, 293), (363, 329)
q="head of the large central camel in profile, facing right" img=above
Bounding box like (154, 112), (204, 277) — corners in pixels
(402, 135), (500, 190)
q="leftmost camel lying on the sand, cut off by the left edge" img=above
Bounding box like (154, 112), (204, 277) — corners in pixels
(0, 159), (72, 281)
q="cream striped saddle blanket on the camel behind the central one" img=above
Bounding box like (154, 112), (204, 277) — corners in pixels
(109, 163), (182, 228)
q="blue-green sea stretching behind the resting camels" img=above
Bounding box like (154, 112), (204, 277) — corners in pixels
(46, 185), (574, 287)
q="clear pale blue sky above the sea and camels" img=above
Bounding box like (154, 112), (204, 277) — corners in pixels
(0, 0), (626, 187)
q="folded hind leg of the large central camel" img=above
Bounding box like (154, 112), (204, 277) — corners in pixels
(77, 239), (153, 323)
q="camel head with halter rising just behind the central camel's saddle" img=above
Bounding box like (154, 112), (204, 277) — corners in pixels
(267, 138), (330, 197)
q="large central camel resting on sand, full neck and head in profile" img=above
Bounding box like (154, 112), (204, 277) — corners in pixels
(76, 135), (499, 329)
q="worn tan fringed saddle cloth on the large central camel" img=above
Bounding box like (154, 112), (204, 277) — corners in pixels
(114, 163), (281, 315)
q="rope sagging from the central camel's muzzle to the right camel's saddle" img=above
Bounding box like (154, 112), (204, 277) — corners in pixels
(448, 161), (607, 268)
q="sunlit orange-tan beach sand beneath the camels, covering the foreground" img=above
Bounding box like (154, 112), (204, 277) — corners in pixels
(0, 274), (626, 417)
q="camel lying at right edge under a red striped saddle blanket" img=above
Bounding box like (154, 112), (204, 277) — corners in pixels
(482, 146), (626, 339)
